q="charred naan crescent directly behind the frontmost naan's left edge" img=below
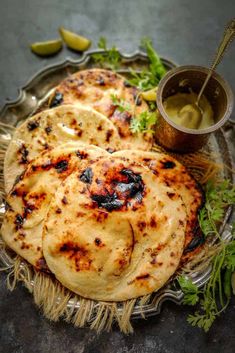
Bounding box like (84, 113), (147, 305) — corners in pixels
(1, 142), (109, 269)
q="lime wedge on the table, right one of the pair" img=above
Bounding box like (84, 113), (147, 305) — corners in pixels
(59, 27), (91, 51)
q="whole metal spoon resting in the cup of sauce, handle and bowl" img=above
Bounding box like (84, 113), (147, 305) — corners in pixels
(178, 18), (235, 129)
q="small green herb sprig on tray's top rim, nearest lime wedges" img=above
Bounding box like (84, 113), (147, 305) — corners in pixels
(92, 37), (121, 70)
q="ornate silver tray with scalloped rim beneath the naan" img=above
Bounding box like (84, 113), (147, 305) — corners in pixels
(0, 50), (235, 319)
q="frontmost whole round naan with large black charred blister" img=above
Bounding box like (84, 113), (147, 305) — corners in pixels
(43, 155), (187, 301)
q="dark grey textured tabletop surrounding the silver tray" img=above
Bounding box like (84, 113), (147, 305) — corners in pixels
(0, 0), (235, 353)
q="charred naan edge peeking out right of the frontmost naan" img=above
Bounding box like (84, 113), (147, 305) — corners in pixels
(113, 150), (204, 262)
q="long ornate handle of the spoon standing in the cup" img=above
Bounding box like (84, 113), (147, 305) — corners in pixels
(197, 18), (235, 104)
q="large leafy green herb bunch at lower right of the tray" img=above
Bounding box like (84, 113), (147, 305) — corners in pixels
(178, 180), (235, 332)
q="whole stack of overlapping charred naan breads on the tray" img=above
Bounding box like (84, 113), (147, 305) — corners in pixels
(1, 69), (202, 301)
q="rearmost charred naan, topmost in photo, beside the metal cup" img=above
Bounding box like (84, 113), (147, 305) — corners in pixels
(50, 69), (152, 150)
